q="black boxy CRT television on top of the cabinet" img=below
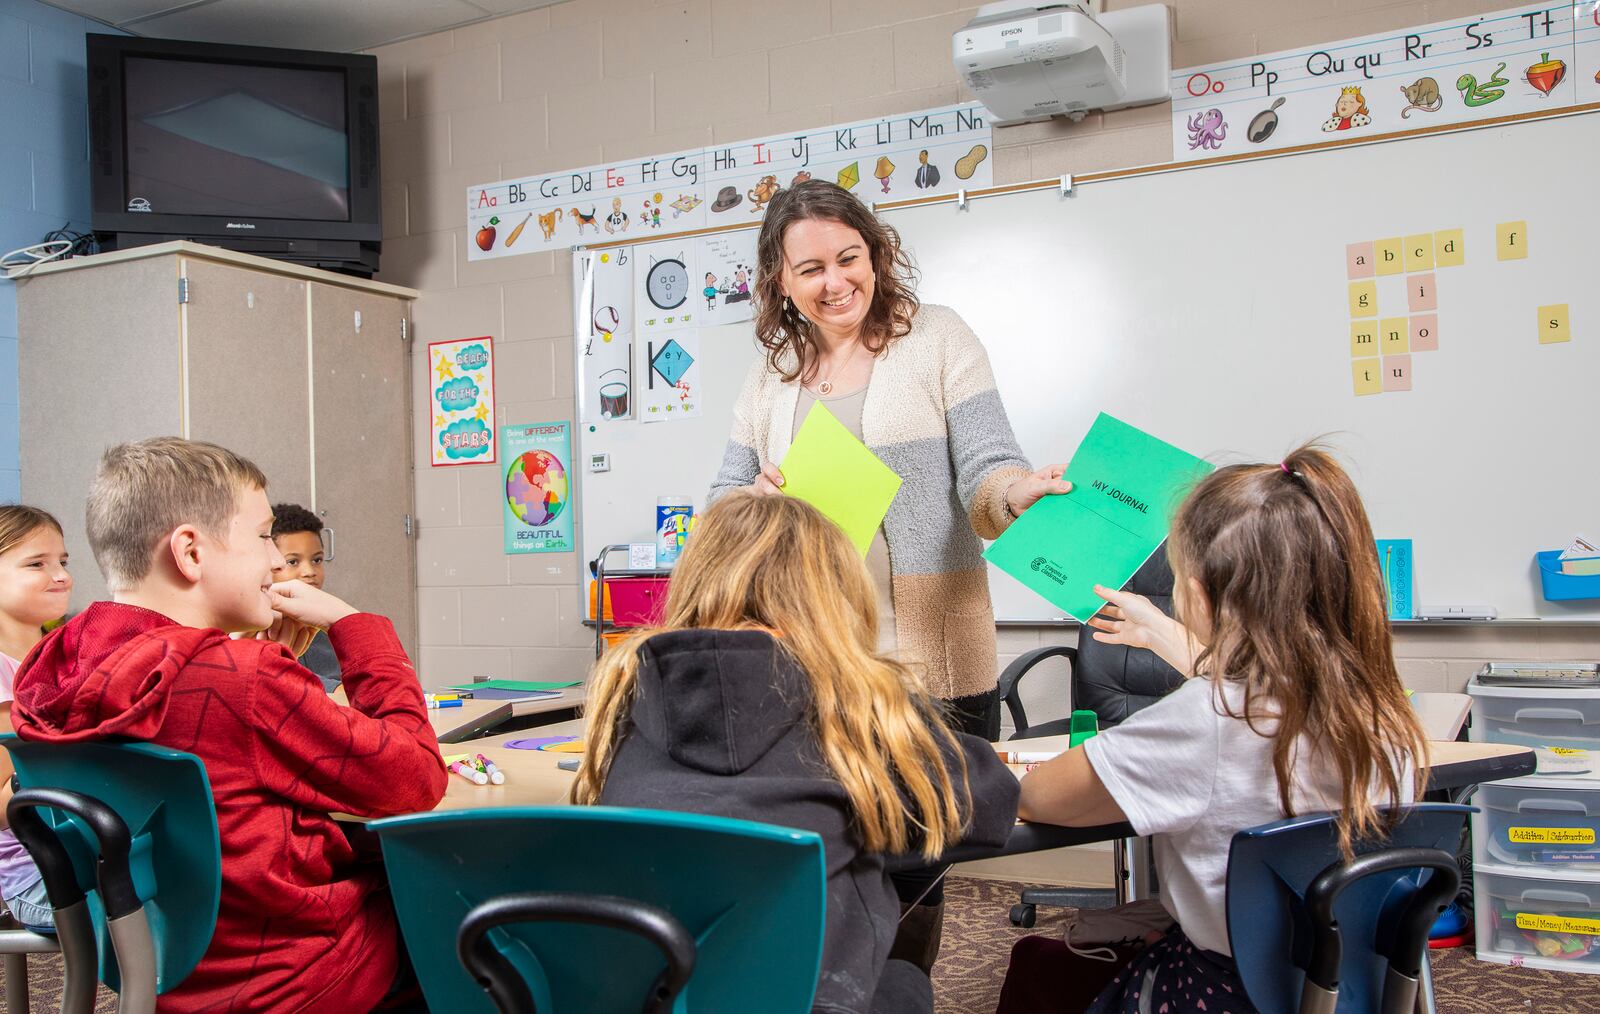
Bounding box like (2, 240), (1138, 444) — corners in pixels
(88, 35), (382, 277)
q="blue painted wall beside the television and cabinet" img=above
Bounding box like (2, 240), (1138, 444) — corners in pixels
(0, 0), (117, 502)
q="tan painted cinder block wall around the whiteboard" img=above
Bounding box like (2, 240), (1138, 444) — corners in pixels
(376, 0), (1600, 715)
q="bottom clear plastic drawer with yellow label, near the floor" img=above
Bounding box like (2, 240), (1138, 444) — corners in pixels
(1475, 867), (1600, 974)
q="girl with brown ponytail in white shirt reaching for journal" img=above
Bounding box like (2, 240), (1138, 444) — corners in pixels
(1000, 446), (1427, 1014)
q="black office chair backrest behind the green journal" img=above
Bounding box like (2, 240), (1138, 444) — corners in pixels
(1072, 542), (1184, 729)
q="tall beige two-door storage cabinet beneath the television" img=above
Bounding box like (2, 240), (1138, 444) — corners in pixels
(18, 243), (416, 657)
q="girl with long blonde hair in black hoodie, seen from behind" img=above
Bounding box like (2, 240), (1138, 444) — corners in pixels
(573, 493), (1018, 1014)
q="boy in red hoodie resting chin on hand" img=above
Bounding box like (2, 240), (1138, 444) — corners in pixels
(14, 437), (446, 1014)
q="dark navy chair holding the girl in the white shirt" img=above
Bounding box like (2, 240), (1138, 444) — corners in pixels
(1227, 803), (1474, 1014)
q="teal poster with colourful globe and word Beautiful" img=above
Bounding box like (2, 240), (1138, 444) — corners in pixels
(501, 422), (573, 553)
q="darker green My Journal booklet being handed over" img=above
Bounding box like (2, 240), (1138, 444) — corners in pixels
(984, 413), (1213, 622)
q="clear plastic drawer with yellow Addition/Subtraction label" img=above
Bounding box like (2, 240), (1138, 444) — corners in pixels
(1472, 777), (1600, 876)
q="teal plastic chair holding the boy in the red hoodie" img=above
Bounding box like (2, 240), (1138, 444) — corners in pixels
(0, 736), (222, 1011)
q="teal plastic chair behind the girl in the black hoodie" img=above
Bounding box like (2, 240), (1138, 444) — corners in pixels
(368, 806), (827, 1014)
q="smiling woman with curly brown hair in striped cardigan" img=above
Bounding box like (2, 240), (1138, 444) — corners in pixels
(709, 179), (1069, 966)
